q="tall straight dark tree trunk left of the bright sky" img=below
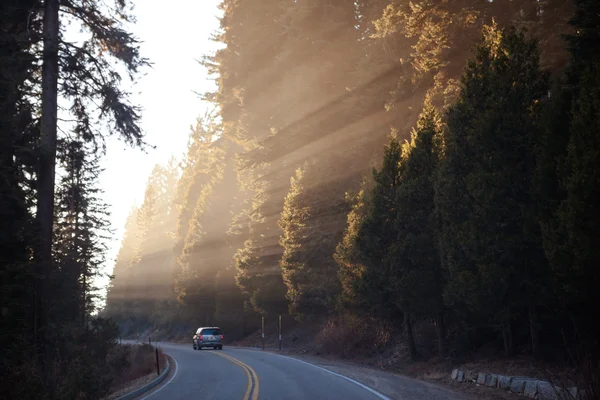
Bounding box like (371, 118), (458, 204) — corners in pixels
(35, 0), (59, 372)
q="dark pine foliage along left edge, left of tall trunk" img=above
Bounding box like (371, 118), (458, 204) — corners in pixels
(0, 0), (41, 382)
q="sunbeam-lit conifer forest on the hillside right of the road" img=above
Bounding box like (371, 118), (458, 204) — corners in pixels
(106, 0), (600, 364)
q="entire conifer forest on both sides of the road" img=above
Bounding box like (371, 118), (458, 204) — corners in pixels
(0, 0), (600, 398)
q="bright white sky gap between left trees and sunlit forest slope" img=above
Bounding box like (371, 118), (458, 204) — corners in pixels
(99, 0), (220, 298)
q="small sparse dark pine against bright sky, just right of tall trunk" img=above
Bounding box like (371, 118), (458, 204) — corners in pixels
(54, 140), (110, 325)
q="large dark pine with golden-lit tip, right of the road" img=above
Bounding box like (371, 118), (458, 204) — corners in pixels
(437, 26), (548, 354)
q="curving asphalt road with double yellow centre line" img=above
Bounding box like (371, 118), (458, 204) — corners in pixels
(134, 343), (388, 400)
